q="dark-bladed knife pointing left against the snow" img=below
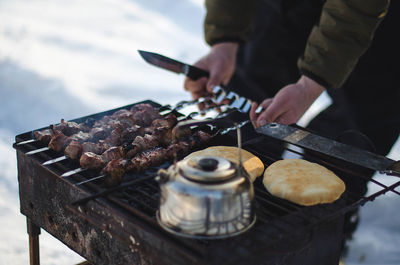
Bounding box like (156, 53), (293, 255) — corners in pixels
(138, 50), (210, 81)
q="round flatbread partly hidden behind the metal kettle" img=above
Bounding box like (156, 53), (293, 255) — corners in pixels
(185, 146), (264, 181)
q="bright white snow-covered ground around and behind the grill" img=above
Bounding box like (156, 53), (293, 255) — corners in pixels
(0, 0), (400, 265)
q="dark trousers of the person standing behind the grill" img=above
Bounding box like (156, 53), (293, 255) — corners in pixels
(228, 0), (400, 256)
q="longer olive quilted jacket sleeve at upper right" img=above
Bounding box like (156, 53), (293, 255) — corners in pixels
(298, 0), (390, 87)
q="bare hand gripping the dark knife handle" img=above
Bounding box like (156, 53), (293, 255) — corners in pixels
(184, 42), (239, 99)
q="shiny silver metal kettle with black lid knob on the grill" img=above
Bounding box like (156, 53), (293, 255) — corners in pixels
(157, 156), (255, 239)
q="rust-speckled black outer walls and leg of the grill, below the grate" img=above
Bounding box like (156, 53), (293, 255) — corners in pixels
(17, 147), (341, 265)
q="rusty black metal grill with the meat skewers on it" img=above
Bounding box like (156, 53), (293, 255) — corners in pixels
(14, 101), (400, 265)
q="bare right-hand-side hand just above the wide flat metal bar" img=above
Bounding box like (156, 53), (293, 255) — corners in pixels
(250, 76), (325, 127)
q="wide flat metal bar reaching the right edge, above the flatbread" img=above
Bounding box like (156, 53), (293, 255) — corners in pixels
(256, 123), (400, 177)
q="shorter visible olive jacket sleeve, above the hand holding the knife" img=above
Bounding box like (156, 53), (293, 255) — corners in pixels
(204, 0), (256, 45)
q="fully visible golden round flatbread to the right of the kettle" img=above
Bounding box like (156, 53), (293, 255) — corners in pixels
(263, 159), (346, 206)
